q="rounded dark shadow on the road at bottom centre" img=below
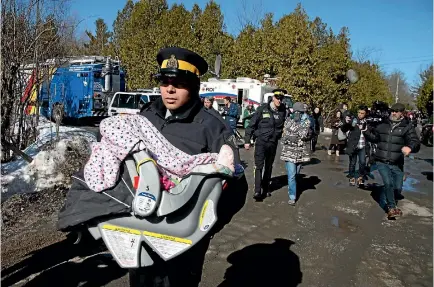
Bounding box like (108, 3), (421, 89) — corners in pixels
(218, 239), (303, 287)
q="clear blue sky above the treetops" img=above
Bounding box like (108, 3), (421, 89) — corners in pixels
(70, 0), (433, 84)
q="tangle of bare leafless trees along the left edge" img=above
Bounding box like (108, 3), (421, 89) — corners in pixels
(1, 0), (74, 161)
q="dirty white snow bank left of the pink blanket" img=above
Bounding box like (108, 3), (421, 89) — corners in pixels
(1, 119), (96, 201)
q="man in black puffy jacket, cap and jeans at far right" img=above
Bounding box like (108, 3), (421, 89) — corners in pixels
(365, 103), (420, 218)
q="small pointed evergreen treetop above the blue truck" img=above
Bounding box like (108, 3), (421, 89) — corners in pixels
(84, 18), (113, 55)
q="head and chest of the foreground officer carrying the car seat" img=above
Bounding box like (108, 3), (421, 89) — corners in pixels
(141, 47), (237, 160)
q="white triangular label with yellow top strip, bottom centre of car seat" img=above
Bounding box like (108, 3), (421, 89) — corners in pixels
(143, 231), (192, 259)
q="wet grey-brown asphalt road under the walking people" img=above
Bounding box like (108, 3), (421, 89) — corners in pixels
(2, 131), (433, 287)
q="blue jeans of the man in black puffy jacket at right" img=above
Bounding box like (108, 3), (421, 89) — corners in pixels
(377, 162), (404, 208)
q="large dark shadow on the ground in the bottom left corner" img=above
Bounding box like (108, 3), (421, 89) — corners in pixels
(1, 235), (127, 287)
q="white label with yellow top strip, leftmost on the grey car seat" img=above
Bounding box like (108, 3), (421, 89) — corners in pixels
(101, 224), (140, 268)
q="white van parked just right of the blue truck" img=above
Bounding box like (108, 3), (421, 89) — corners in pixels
(108, 92), (161, 116)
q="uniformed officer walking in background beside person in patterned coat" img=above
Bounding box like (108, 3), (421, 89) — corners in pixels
(244, 89), (287, 200)
